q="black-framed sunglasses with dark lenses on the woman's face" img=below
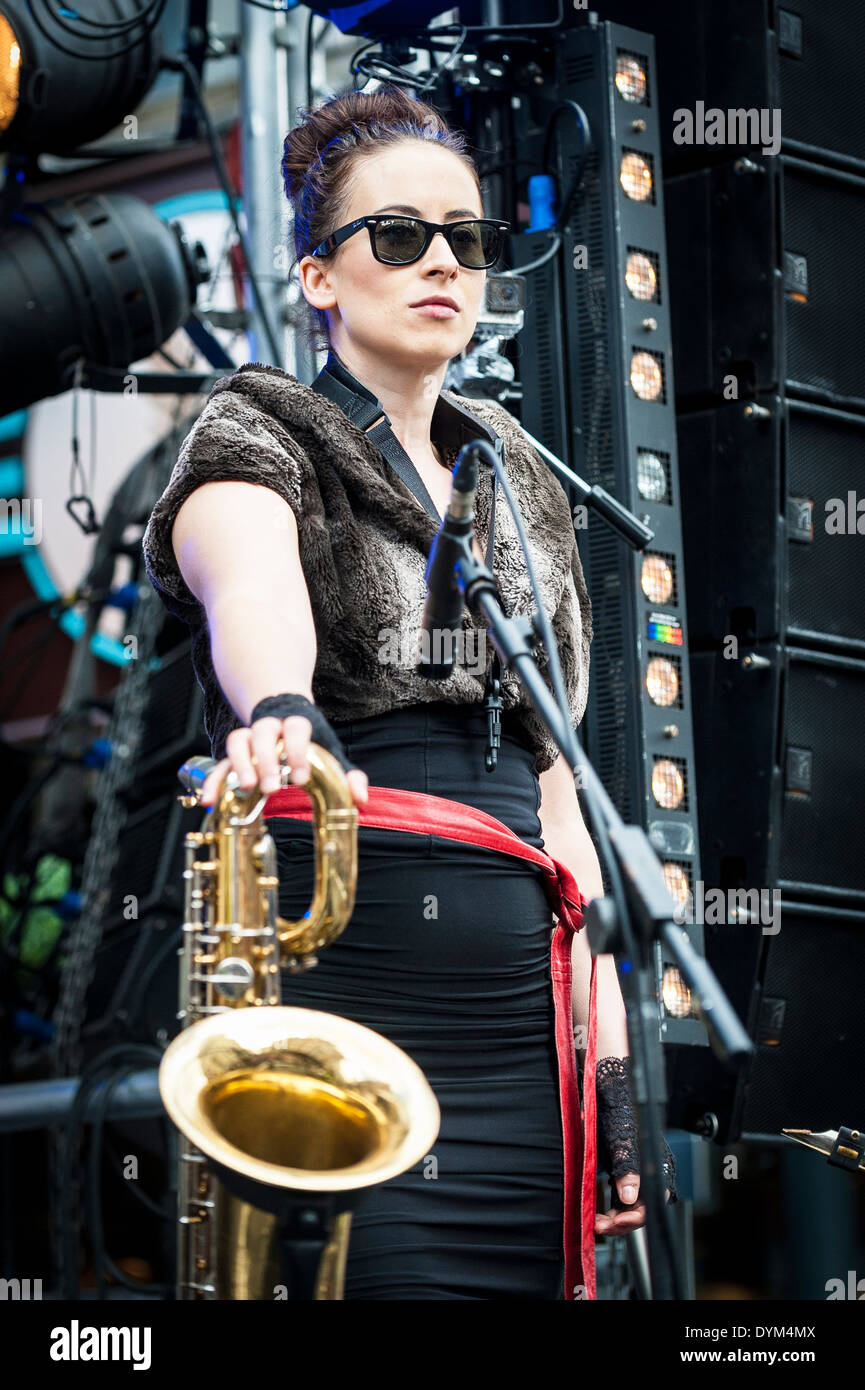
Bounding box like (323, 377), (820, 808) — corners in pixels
(312, 214), (510, 270)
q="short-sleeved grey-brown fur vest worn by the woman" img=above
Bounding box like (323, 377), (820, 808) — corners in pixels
(142, 363), (591, 773)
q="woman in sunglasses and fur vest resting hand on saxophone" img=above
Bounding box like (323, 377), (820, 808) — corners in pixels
(145, 89), (674, 1300)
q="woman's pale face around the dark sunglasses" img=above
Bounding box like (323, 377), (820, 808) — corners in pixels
(299, 139), (487, 371)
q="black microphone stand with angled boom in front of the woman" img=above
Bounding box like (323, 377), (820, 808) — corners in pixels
(452, 439), (754, 1300)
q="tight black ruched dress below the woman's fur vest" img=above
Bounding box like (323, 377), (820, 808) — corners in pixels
(267, 702), (563, 1300)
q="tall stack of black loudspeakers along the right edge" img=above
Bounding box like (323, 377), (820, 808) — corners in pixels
(613, 0), (865, 1140)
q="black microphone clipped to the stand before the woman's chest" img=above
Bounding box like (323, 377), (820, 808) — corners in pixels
(417, 443), (478, 681)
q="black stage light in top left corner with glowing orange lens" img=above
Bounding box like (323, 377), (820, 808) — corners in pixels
(0, 0), (165, 154)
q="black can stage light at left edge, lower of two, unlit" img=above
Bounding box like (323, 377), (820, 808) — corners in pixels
(0, 193), (206, 416)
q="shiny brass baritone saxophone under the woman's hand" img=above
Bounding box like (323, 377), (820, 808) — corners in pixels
(159, 744), (439, 1300)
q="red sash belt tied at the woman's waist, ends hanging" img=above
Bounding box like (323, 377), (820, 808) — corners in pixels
(264, 785), (598, 1301)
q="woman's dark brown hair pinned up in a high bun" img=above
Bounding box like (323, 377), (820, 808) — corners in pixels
(281, 85), (481, 350)
